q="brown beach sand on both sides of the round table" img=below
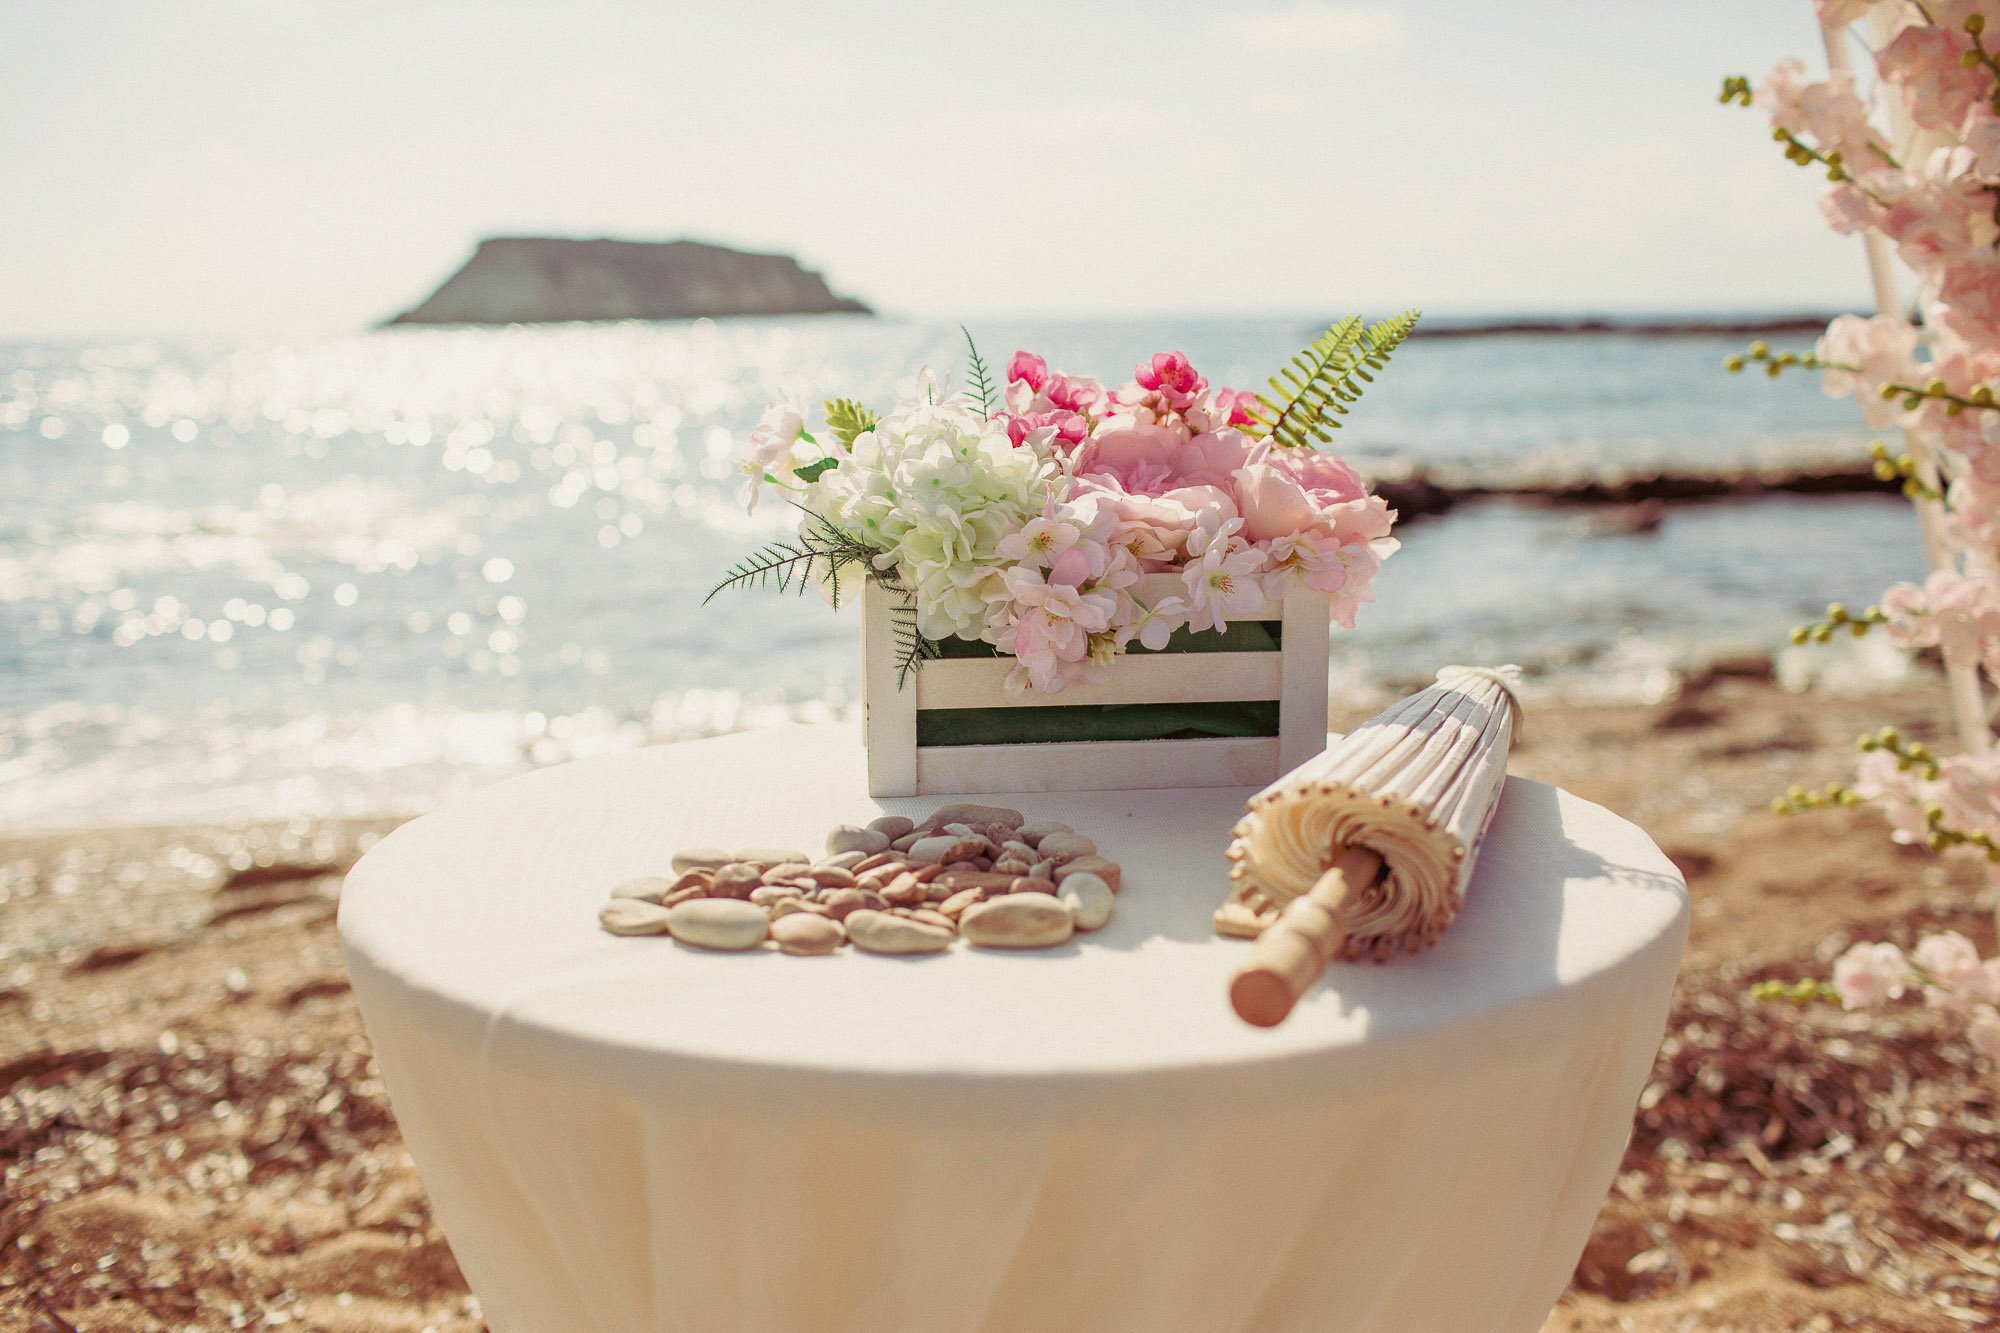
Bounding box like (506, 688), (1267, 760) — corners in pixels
(0, 664), (2000, 1333)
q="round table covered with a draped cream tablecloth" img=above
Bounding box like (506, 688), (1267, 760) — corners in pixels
(340, 727), (1688, 1333)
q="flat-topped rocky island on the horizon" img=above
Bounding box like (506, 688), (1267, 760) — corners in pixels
(388, 236), (872, 324)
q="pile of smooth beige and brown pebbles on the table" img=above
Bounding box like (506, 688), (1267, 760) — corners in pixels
(598, 805), (1120, 955)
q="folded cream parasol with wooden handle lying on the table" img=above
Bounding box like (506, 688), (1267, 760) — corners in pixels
(1216, 667), (1520, 1027)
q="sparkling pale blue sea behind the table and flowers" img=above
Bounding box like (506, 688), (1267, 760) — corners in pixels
(0, 316), (1922, 829)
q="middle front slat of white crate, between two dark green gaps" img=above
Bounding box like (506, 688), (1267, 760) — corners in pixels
(916, 652), (1280, 712)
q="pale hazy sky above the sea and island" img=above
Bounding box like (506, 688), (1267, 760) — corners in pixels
(0, 0), (1866, 336)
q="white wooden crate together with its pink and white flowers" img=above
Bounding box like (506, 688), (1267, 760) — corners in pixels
(710, 322), (1416, 795)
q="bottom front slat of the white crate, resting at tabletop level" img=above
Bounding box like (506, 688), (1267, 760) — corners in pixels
(916, 732), (1280, 795)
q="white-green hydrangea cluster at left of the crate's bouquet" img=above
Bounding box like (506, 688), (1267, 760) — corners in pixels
(804, 372), (1056, 638)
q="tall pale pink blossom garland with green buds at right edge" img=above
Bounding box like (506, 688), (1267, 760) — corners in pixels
(1722, 0), (2000, 1057)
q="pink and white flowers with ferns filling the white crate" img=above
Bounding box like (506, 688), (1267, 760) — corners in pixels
(710, 320), (1418, 695)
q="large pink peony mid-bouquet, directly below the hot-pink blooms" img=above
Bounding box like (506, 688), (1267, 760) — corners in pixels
(1070, 426), (1250, 568)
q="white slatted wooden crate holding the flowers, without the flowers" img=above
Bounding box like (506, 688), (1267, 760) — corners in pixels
(862, 574), (1330, 797)
